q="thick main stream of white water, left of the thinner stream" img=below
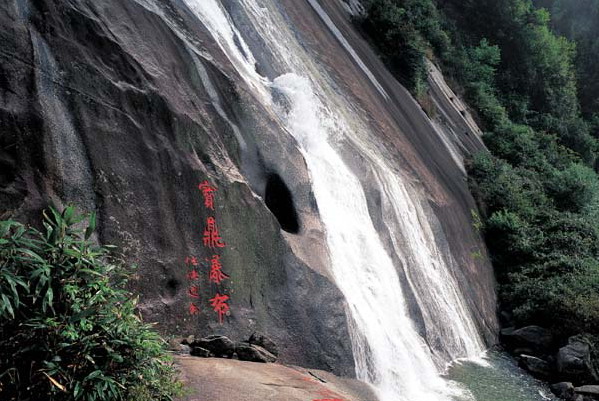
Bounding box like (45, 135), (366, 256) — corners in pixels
(274, 74), (468, 401)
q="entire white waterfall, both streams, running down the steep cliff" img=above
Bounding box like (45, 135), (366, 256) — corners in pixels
(185, 0), (482, 401)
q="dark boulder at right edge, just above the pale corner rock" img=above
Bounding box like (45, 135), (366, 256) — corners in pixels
(557, 337), (599, 384)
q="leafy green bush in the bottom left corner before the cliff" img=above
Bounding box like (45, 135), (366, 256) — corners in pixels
(0, 207), (181, 401)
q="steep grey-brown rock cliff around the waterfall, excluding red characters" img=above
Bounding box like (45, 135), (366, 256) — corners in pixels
(0, 0), (497, 386)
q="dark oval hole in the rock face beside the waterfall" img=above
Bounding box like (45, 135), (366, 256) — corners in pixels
(264, 173), (300, 234)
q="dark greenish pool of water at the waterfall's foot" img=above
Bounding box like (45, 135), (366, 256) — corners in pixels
(447, 351), (558, 401)
